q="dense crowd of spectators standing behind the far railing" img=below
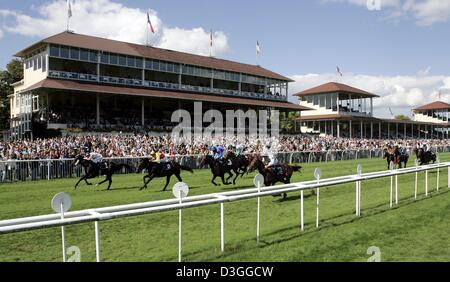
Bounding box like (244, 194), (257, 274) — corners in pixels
(0, 134), (450, 160)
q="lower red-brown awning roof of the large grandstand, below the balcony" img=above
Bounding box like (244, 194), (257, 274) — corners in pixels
(23, 78), (310, 111)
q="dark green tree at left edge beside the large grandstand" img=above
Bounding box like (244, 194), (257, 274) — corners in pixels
(0, 59), (23, 130)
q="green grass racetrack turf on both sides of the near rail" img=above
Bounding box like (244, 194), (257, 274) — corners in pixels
(0, 154), (450, 262)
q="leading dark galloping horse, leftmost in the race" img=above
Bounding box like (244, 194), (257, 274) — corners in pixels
(72, 155), (132, 190)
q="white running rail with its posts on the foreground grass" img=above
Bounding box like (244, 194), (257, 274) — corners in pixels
(0, 162), (450, 261)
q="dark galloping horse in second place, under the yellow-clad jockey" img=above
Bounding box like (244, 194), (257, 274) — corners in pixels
(138, 159), (194, 191)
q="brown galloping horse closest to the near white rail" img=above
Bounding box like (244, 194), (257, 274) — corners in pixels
(249, 158), (302, 198)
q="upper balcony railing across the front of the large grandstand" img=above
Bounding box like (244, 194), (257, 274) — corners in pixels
(48, 70), (287, 101)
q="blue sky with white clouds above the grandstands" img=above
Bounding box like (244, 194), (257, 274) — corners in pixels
(0, 0), (450, 117)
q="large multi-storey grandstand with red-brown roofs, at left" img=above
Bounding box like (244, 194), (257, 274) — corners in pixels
(10, 32), (308, 138)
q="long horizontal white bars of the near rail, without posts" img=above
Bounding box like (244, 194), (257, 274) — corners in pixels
(0, 162), (450, 234)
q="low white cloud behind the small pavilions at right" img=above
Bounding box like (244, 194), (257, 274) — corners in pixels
(290, 71), (450, 117)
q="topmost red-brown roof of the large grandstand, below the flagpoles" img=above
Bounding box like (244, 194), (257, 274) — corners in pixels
(15, 31), (293, 82)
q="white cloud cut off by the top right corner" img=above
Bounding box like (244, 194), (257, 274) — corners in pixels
(324, 0), (450, 26)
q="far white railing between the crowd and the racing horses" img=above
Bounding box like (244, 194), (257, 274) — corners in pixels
(0, 146), (450, 183)
